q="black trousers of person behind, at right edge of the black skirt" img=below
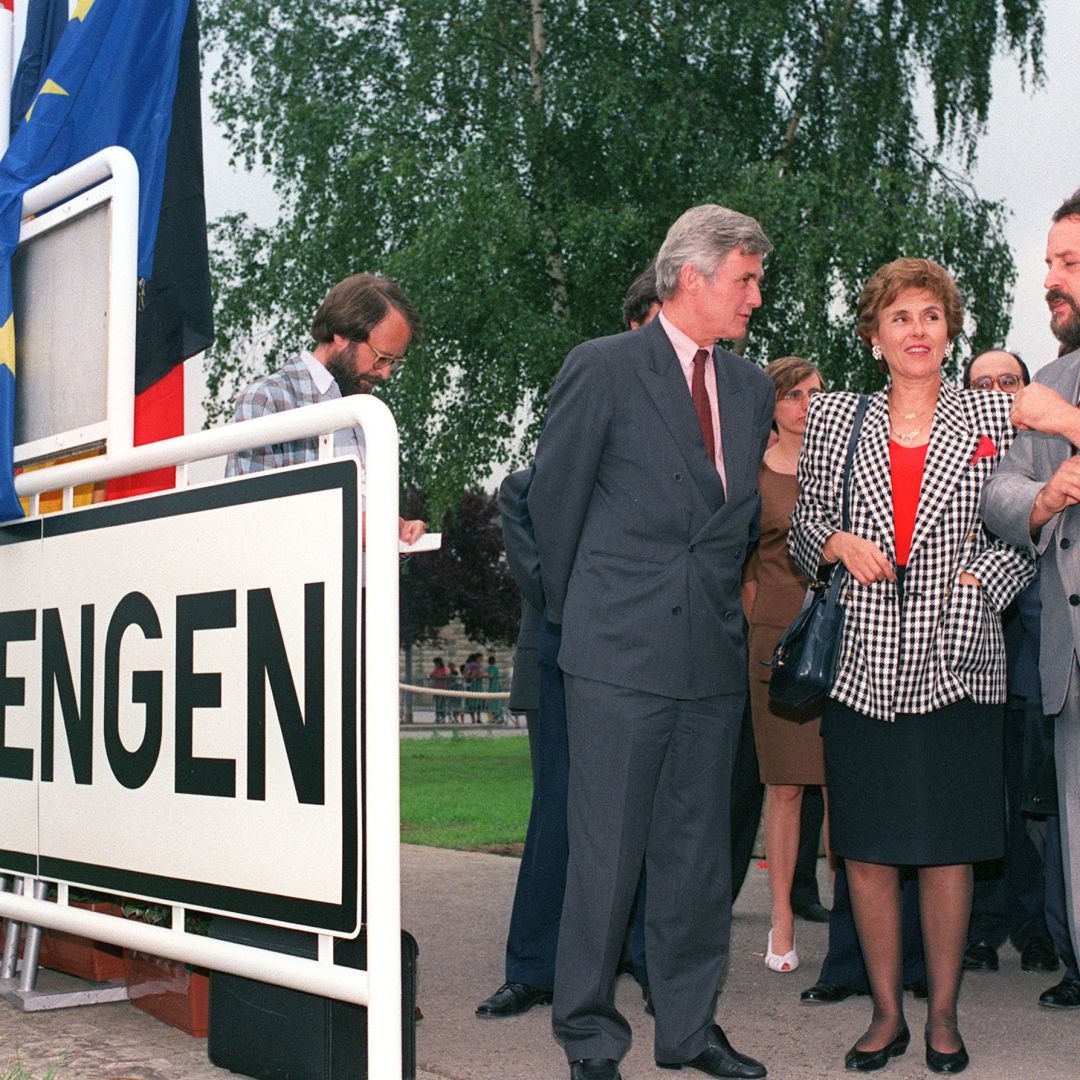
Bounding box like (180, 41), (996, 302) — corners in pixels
(968, 708), (1047, 949)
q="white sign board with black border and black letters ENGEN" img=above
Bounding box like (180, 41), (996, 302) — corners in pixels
(0, 458), (361, 935)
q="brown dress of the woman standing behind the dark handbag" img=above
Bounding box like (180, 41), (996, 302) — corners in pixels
(743, 463), (825, 784)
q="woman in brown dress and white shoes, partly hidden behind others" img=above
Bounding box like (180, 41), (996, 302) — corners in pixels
(743, 356), (825, 972)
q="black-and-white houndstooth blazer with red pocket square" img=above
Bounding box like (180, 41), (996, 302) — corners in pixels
(787, 386), (1035, 720)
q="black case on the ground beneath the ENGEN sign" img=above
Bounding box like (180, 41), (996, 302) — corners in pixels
(206, 918), (419, 1080)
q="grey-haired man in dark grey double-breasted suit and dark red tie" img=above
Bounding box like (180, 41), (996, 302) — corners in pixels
(528, 205), (775, 1080)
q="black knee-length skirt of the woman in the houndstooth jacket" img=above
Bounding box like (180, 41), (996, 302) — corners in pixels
(821, 699), (1005, 866)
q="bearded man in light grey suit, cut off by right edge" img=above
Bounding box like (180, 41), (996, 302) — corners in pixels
(983, 190), (1080, 1023)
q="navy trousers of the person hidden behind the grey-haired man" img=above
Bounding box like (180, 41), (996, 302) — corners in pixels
(507, 620), (648, 990)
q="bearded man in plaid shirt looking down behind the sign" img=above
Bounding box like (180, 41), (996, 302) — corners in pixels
(225, 273), (424, 543)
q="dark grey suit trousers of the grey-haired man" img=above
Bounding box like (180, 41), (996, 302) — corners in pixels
(552, 675), (745, 1064)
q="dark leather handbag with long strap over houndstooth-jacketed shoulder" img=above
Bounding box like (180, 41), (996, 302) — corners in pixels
(769, 394), (869, 708)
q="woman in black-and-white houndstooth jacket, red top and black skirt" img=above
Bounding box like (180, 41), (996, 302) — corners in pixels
(788, 259), (1035, 1072)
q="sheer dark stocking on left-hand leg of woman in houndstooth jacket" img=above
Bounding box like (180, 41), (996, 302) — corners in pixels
(847, 859), (902, 1050)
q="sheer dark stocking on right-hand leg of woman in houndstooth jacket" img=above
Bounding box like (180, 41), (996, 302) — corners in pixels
(919, 864), (972, 1054)
